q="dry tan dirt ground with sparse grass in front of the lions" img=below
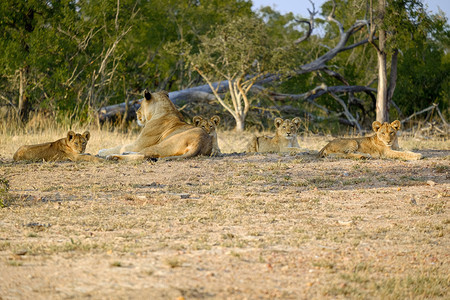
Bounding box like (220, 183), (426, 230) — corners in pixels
(0, 134), (450, 299)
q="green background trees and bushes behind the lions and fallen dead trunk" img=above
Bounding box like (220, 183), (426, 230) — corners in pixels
(0, 0), (450, 132)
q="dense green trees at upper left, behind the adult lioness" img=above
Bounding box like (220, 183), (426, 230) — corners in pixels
(0, 0), (252, 119)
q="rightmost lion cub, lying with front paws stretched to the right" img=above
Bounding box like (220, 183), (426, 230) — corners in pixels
(318, 120), (422, 160)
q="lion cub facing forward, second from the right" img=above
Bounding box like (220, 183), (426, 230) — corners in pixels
(247, 117), (300, 152)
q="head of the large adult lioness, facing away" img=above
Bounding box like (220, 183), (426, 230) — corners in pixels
(136, 90), (183, 126)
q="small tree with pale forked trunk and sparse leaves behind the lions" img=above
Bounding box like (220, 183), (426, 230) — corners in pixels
(187, 17), (283, 131)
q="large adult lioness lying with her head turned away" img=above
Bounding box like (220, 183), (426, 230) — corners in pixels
(98, 90), (212, 160)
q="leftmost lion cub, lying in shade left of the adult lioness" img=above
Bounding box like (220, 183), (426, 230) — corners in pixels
(13, 131), (101, 161)
